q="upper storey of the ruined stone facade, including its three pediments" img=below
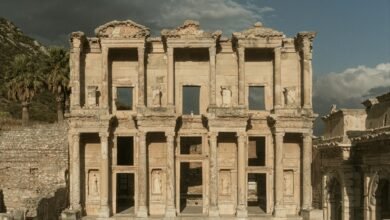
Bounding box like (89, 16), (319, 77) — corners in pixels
(70, 20), (315, 118)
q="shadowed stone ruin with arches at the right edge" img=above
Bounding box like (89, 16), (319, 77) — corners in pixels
(313, 92), (390, 220)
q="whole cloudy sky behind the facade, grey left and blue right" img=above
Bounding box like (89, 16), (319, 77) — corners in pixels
(0, 0), (390, 133)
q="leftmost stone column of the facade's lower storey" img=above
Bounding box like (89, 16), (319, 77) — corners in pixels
(71, 133), (81, 210)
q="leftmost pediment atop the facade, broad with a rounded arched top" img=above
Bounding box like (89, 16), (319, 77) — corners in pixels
(95, 20), (150, 38)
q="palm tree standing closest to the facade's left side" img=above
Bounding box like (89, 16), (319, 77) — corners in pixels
(43, 47), (69, 122)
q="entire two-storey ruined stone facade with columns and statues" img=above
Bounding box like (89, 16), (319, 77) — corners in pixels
(64, 20), (315, 219)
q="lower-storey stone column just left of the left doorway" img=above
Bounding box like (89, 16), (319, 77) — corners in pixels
(99, 132), (110, 218)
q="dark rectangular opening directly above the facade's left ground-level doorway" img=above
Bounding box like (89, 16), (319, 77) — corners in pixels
(117, 137), (134, 166)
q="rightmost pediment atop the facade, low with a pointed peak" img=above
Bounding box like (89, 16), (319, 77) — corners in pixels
(233, 22), (284, 39)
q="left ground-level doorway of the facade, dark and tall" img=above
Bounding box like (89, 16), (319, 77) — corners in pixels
(116, 173), (134, 214)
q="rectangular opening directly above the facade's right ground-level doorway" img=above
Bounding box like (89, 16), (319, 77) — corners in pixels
(248, 137), (266, 166)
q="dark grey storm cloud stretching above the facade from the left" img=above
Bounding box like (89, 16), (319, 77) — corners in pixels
(0, 0), (273, 45)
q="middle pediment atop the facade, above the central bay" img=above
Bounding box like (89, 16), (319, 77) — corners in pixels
(161, 20), (222, 39)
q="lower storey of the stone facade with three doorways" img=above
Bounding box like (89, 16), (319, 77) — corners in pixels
(64, 116), (311, 219)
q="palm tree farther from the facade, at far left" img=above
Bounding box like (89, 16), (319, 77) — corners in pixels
(6, 54), (44, 126)
